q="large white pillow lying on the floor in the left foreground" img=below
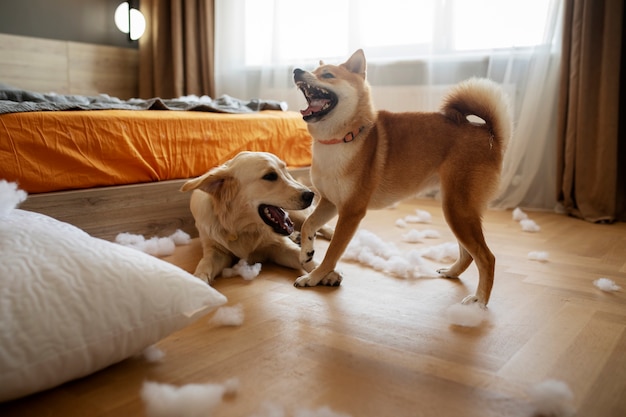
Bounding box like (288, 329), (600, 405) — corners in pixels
(0, 210), (226, 401)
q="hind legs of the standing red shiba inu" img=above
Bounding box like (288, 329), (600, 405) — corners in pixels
(441, 199), (496, 305)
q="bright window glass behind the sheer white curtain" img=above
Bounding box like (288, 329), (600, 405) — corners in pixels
(245, 0), (550, 66)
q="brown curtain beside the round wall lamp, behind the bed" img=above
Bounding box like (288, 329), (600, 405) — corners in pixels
(139, 0), (215, 98)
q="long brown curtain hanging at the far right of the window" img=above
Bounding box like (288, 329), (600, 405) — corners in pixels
(557, 0), (626, 222)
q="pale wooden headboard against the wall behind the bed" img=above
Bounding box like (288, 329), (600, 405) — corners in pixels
(0, 33), (139, 99)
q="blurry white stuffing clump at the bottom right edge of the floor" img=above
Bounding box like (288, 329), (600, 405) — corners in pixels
(529, 379), (575, 417)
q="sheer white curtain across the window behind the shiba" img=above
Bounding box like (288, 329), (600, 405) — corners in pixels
(215, 0), (564, 209)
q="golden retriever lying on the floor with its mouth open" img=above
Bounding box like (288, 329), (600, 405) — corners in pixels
(181, 152), (332, 284)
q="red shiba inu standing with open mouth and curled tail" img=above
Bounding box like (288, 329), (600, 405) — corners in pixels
(294, 50), (512, 305)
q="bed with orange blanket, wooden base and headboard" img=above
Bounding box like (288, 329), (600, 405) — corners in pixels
(0, 35), (311, 240)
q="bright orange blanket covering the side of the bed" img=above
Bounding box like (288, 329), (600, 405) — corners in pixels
(0, 110), (311, 193)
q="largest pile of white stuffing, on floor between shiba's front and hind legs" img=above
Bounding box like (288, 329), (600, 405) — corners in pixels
(343, 230), (456, 278)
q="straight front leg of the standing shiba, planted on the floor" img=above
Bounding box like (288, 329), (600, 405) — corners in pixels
(294, 204), (367, 287)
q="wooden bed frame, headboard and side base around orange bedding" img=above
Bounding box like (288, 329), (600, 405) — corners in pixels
(0, 34), (309, 240)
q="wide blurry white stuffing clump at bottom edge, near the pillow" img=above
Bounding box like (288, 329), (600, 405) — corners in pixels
(141, 379), (239, 417)
